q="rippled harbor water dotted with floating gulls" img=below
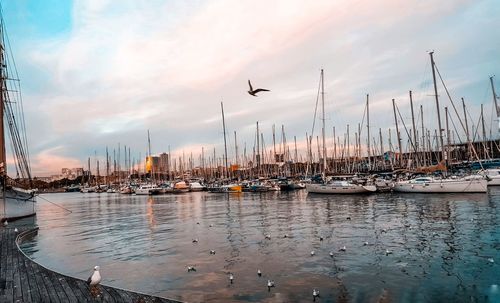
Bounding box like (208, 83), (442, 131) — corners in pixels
(17, 188), (500, 302)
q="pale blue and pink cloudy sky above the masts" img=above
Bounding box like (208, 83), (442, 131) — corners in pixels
(2, 0), (500, 176)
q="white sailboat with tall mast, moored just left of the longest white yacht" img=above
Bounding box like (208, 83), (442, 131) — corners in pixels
(306, 70), (377, 194)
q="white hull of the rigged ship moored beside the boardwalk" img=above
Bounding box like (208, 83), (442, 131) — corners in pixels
(0, 189), (36, 221)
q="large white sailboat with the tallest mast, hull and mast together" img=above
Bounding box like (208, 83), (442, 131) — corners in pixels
(393, 52), (488, 193)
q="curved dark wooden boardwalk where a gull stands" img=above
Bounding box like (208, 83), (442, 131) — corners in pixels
(0, 226), (183, 303)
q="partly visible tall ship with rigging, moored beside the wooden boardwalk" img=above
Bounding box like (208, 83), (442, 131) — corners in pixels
(0, 11), (36, 221)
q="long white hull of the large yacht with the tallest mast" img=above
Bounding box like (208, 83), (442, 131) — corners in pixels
(393, 179), (488, 193)
